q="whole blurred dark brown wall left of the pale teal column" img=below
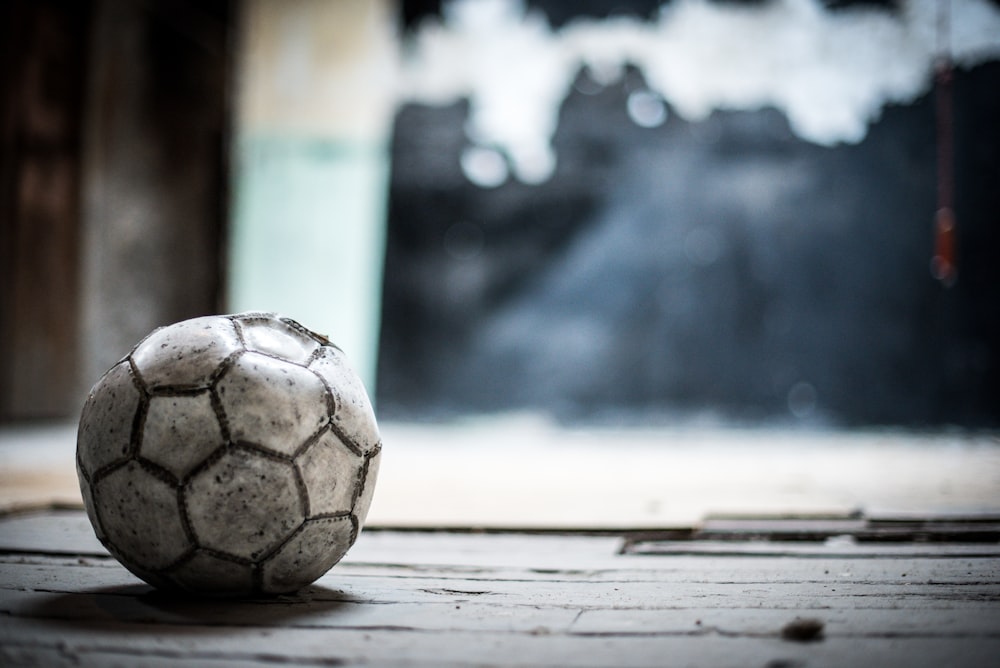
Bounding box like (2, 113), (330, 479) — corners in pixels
(0, 0), (233, 420)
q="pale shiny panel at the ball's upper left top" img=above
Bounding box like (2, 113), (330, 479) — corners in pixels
(132, 316), (241, 390)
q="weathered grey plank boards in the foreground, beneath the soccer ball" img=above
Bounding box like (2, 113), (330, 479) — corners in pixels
(0, 511), (1000, 667)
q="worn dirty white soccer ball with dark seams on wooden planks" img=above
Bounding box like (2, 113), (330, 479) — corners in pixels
(76, 313), (381, 596)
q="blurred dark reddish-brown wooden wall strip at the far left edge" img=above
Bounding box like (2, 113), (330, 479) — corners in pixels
(0, 0), (91, 419)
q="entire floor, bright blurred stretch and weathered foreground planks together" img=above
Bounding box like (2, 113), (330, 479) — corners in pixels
(0, 420), (1000, 668)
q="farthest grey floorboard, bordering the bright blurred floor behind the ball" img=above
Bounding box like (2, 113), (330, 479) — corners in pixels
(0, 510), (1000, 582)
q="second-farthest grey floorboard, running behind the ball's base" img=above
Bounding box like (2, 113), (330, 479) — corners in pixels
(0, 561), (1000, 616)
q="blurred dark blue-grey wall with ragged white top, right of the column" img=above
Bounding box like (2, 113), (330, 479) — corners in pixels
(378, 0), (1000, 427)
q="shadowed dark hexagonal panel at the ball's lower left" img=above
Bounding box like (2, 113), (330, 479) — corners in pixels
(94, 461), (190, 571)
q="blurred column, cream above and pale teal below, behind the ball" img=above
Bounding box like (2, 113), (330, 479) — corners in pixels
(228, 0), (396, 393)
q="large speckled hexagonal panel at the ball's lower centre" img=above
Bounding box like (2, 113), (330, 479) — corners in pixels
(184, 448), (305, 559)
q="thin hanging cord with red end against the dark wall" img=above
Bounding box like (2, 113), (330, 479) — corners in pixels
(931, 0), (958, 287)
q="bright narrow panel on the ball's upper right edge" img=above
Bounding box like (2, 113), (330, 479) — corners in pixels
(309, 346), (380, 452)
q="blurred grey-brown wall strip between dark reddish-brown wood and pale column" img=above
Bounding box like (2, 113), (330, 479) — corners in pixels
(81, 0), (232, 396)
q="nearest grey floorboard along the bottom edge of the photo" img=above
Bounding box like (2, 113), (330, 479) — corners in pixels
(0, 619), (1000, 668)
